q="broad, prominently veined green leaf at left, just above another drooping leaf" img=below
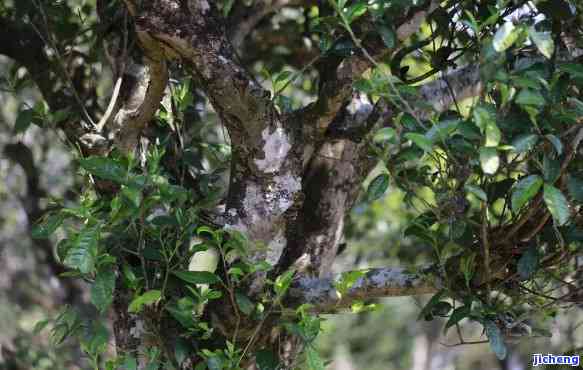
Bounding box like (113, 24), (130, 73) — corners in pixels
(63, 229), (99, 274)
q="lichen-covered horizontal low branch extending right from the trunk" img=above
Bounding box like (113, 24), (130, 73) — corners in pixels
(289, 267), (441, 313)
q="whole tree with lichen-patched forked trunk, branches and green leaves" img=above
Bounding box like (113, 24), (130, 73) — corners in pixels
(0, 0), (583, 369)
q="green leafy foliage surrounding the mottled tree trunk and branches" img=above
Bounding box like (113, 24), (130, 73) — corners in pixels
(0, 0), (583, 370)
